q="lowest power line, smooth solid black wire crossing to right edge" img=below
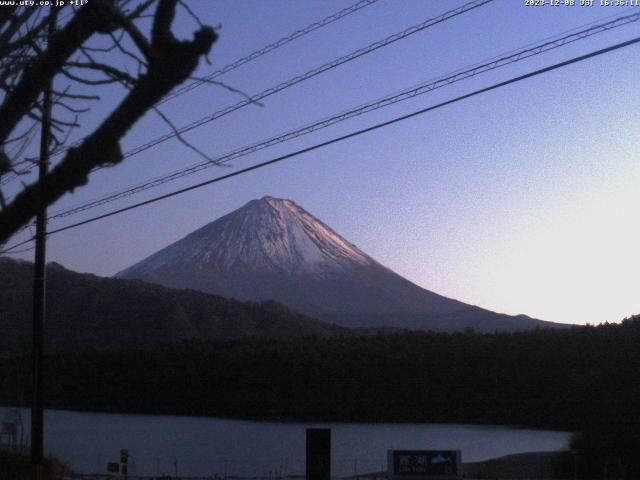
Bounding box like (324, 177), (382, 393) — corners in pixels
(0, 33), (640, 254)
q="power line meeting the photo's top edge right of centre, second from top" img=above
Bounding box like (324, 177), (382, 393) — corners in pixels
(47, 0), (494, 164)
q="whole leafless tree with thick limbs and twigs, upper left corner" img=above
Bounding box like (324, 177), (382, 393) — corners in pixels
(0, 0), (217, 245)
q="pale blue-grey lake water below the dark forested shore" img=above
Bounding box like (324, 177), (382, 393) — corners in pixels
(0, 408), (569, 476)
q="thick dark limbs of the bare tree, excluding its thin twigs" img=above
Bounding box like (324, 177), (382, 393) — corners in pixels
(0, 0), (217, 244)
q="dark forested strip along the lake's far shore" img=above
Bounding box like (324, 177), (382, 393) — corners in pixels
(0, 317), (640, 430)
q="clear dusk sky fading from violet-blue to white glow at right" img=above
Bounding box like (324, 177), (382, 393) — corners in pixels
(1, 0), (640, 324)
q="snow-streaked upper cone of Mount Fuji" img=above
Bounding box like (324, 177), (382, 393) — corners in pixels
(118, 197), (375, 277)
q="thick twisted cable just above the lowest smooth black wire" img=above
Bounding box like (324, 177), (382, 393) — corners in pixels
(49, 13), (640, 220)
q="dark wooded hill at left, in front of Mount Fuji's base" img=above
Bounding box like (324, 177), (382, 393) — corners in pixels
(0, 258), (345, 353)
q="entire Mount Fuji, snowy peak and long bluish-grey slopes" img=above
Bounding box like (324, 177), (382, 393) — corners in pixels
(116, 197), (560, 332)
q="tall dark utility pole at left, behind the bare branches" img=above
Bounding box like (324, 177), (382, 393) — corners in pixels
(31, 6), (56, 480)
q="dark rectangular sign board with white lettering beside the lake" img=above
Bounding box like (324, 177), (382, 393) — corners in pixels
(387, 450), (462, 480)
